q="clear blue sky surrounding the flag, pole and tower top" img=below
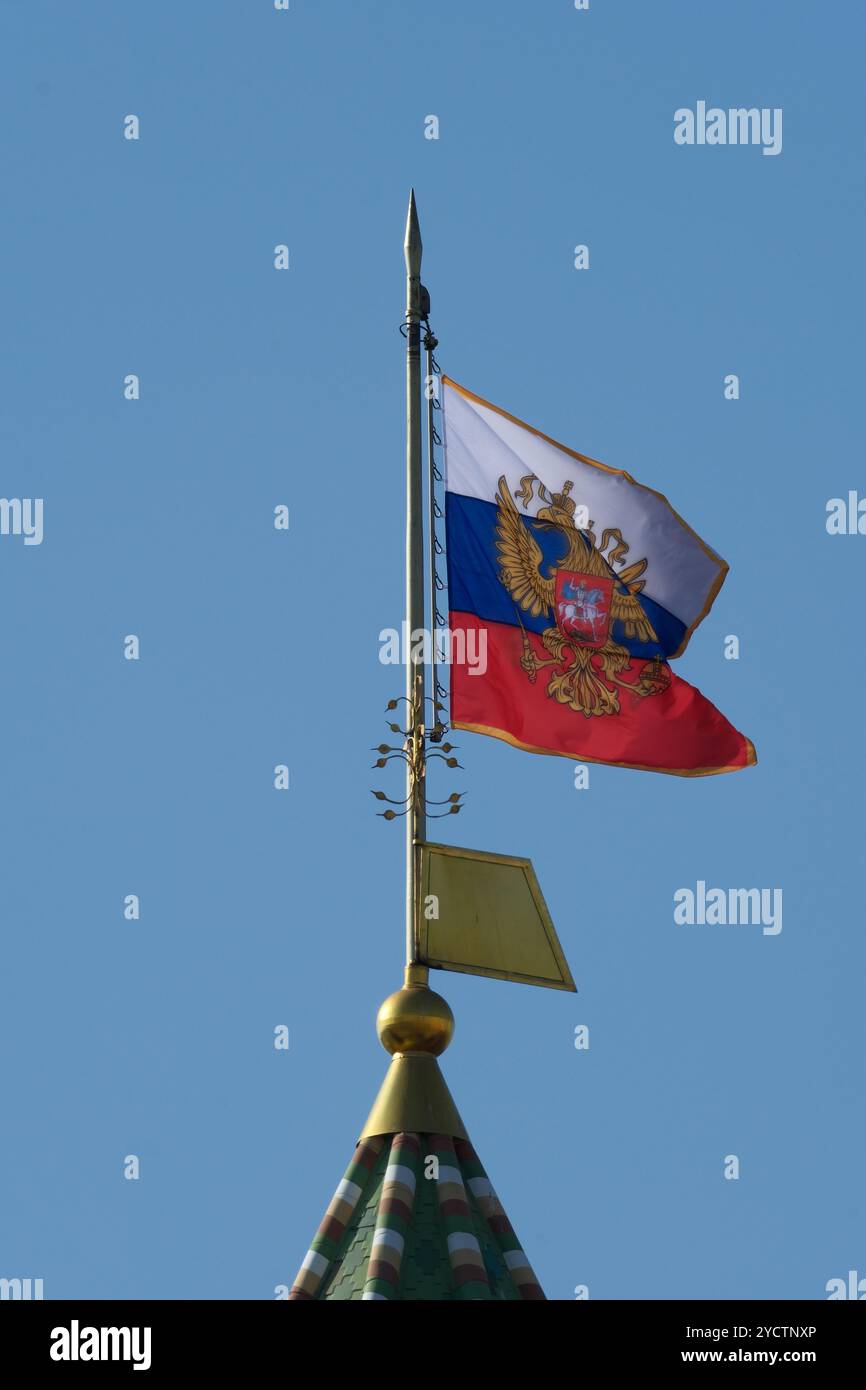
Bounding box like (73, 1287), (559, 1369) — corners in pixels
(0, 0), (866, 1298)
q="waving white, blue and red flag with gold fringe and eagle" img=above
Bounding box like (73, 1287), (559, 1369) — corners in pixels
(442, 377), (756, 777)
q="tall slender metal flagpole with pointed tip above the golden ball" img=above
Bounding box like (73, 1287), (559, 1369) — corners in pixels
(403, 189), (427, 966)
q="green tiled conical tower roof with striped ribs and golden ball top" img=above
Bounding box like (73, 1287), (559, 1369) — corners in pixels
(289, 965), (545, 1301)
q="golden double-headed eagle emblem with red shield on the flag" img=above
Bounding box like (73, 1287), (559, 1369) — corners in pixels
(496, 474), (670, 719)
